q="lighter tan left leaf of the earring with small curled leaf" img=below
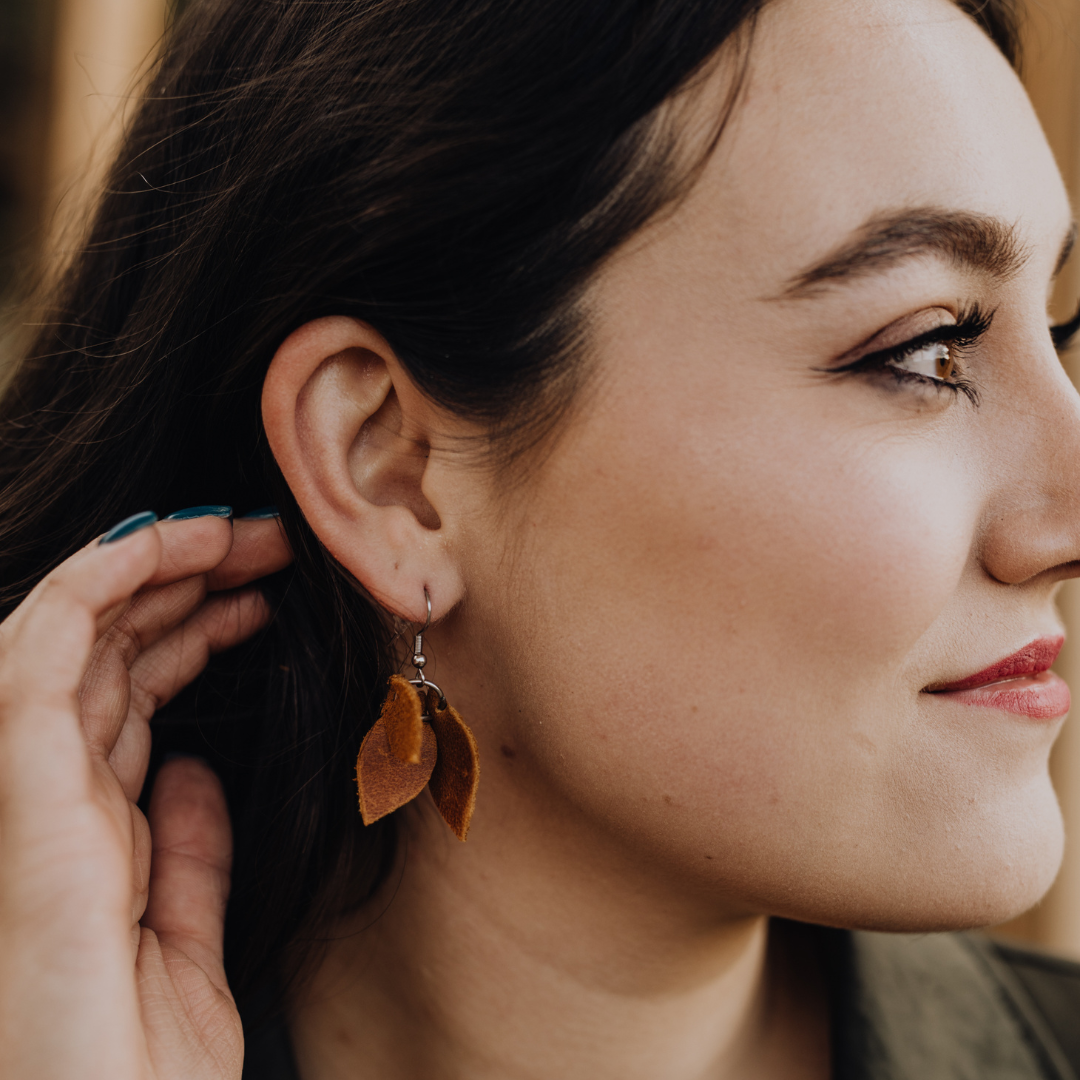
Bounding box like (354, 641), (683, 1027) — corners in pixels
(356, 675), (437, 825)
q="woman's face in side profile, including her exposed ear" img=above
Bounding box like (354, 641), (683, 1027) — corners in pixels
(264, 0), (1080, 930)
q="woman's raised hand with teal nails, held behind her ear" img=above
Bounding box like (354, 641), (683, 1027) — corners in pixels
(0, 517), (291, 1080)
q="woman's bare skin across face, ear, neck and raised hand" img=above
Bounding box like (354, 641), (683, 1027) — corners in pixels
(0, 0), (1080, 1080)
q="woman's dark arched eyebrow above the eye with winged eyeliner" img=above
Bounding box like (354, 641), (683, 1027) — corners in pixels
(781, 207), (1032, 298)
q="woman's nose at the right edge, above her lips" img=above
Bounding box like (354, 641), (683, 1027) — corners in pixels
(978, 328), (1080, 585)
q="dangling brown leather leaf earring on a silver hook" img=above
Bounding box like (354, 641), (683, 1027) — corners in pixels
(356, 588), (480, 840)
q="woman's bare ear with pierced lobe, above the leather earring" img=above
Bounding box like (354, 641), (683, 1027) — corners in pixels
(262, 316), (463, 622)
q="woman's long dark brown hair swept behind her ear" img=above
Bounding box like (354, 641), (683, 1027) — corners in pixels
(0, 0), (1016, 988)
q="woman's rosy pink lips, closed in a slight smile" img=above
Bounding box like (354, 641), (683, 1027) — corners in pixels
(927, 635), (1069, 720)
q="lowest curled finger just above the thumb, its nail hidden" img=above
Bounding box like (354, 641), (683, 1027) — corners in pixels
(107, 590), (270, 800)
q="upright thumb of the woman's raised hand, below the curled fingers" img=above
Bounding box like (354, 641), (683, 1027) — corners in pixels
(143, 757), (232, 993)
